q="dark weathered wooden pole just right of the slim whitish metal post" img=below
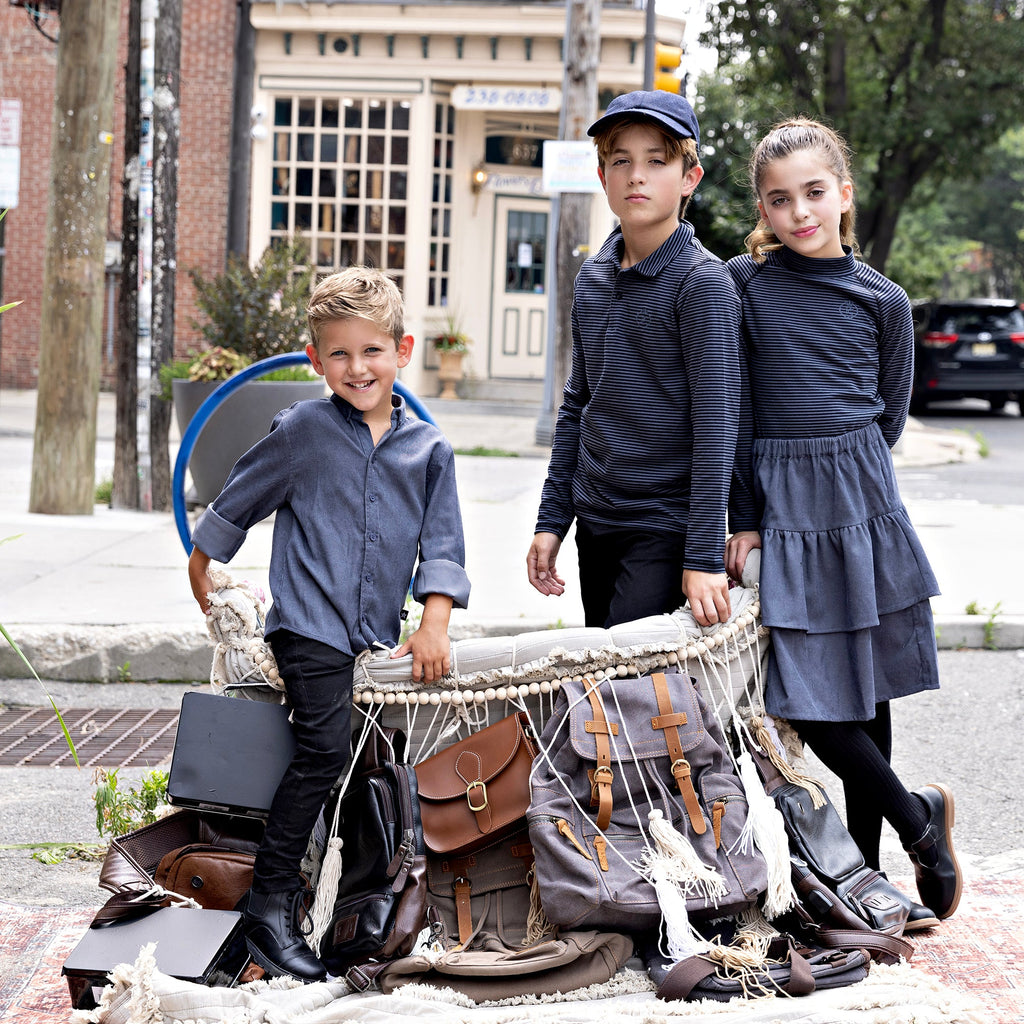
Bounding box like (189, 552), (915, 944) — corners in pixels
(150, 0), (181, 512)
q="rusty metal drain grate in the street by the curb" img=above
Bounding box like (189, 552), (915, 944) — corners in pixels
(0, 708), (178, 768)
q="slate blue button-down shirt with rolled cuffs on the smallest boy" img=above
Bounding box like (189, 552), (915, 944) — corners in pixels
(193, 387), (470, 654)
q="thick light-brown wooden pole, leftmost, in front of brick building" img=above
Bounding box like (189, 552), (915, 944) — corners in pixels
(29, 0), (120, 514)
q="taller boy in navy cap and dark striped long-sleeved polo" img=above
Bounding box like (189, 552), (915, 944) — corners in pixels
(526, 91), (756, 628)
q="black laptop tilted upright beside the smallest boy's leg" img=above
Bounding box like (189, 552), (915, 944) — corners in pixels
(167, 691), (295, 817)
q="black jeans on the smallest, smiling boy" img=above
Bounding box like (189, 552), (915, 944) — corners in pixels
(253, 630), (355, 892)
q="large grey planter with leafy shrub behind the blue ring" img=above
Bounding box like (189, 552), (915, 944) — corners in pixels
(160, 240), (324, 505)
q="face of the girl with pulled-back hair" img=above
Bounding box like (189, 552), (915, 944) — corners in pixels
(758, 150), (853, 258)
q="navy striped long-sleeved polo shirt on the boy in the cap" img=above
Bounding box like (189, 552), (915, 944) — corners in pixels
(537, 223), (756, 572)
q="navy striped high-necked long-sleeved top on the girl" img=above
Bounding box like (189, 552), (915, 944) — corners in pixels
(727, 248), (913, 447)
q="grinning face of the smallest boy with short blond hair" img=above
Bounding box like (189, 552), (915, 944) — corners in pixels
(306, 318), (413, 424)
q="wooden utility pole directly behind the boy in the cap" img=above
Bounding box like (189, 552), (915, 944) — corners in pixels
(536, 0), (601, 444)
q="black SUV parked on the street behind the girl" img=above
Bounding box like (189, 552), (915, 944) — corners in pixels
(910, 299), (1024, 416)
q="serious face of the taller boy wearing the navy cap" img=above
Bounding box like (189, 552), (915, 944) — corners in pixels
(598, 122), (703, 252)
